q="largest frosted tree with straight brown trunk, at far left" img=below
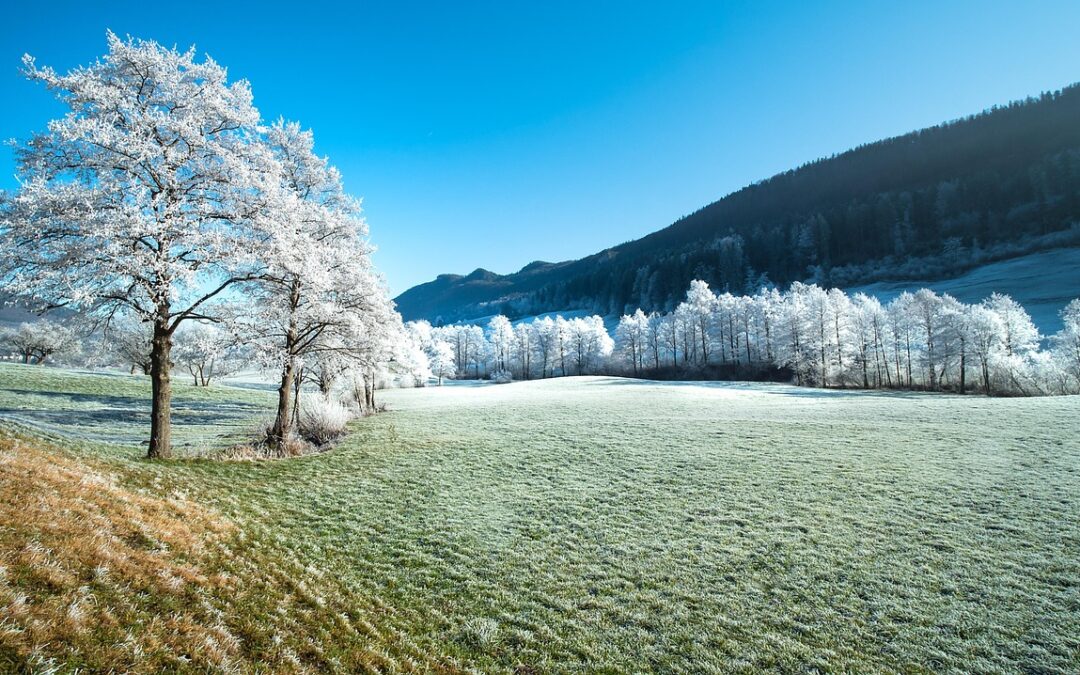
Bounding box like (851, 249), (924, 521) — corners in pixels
(0, 32), (275, 458)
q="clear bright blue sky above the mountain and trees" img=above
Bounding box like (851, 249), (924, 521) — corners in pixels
(0, 0), (1080, 294)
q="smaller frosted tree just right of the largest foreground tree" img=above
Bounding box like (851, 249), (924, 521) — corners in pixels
(242, 121), (384, 447)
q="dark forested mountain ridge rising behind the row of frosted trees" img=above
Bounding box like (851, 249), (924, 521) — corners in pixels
(396, 84), (1080, 322)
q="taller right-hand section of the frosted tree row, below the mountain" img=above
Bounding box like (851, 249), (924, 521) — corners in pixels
(616, 281), (1080, 395)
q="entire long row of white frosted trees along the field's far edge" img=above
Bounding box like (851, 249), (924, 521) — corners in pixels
(407, 281), (1080, 395)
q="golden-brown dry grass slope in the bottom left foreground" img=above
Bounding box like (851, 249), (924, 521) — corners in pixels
(0, 430), (459, 673)
